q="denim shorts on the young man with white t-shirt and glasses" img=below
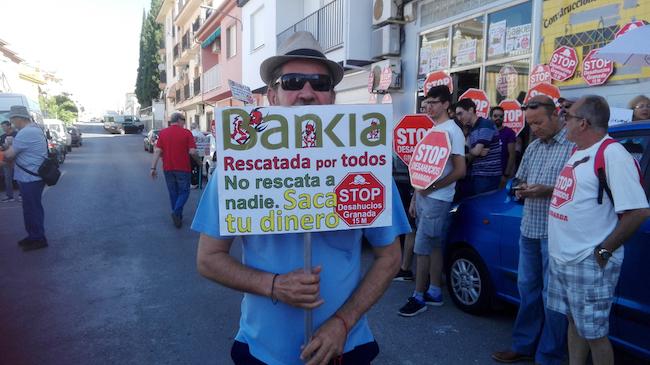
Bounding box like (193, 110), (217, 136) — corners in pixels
(413, 194), (451, 255)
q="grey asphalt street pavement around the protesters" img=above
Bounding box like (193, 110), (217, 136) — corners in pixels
(0, 123), (636, 365)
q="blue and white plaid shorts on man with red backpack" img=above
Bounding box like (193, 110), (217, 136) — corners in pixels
(546, 254), (622, 340)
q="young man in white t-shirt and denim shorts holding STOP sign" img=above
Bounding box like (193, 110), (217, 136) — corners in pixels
(398, 86), (466, 317)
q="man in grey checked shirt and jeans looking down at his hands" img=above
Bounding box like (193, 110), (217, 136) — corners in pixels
(492, 95), (573, 365)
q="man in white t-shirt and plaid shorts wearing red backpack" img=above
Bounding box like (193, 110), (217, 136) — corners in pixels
(547, 95), (650, 365)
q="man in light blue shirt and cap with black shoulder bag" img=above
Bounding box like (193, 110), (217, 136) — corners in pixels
(5, 105), (47, 251)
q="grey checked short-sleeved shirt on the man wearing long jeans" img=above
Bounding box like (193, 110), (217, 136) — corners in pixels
(516, 128), (574, 238)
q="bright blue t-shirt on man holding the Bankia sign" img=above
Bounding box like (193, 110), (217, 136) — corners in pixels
(192, 178), (411, 365)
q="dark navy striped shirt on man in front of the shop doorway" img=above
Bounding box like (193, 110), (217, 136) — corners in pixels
(468, 118), (503, 176)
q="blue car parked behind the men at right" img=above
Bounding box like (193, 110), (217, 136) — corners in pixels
(445, 121), (650, 359)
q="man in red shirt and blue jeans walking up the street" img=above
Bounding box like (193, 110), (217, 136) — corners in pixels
(151, 113), (196, 228)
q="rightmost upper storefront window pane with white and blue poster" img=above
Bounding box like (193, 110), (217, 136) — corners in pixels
(487, 1), (532, 61)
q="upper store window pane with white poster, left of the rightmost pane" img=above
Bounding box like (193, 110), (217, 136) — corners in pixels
(451, 16), (484, 67)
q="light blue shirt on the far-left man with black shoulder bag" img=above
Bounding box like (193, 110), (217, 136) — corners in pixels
(12, 123), (47, 182)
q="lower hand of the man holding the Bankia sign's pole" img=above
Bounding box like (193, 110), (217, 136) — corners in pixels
(300, 317), (347, 365)
